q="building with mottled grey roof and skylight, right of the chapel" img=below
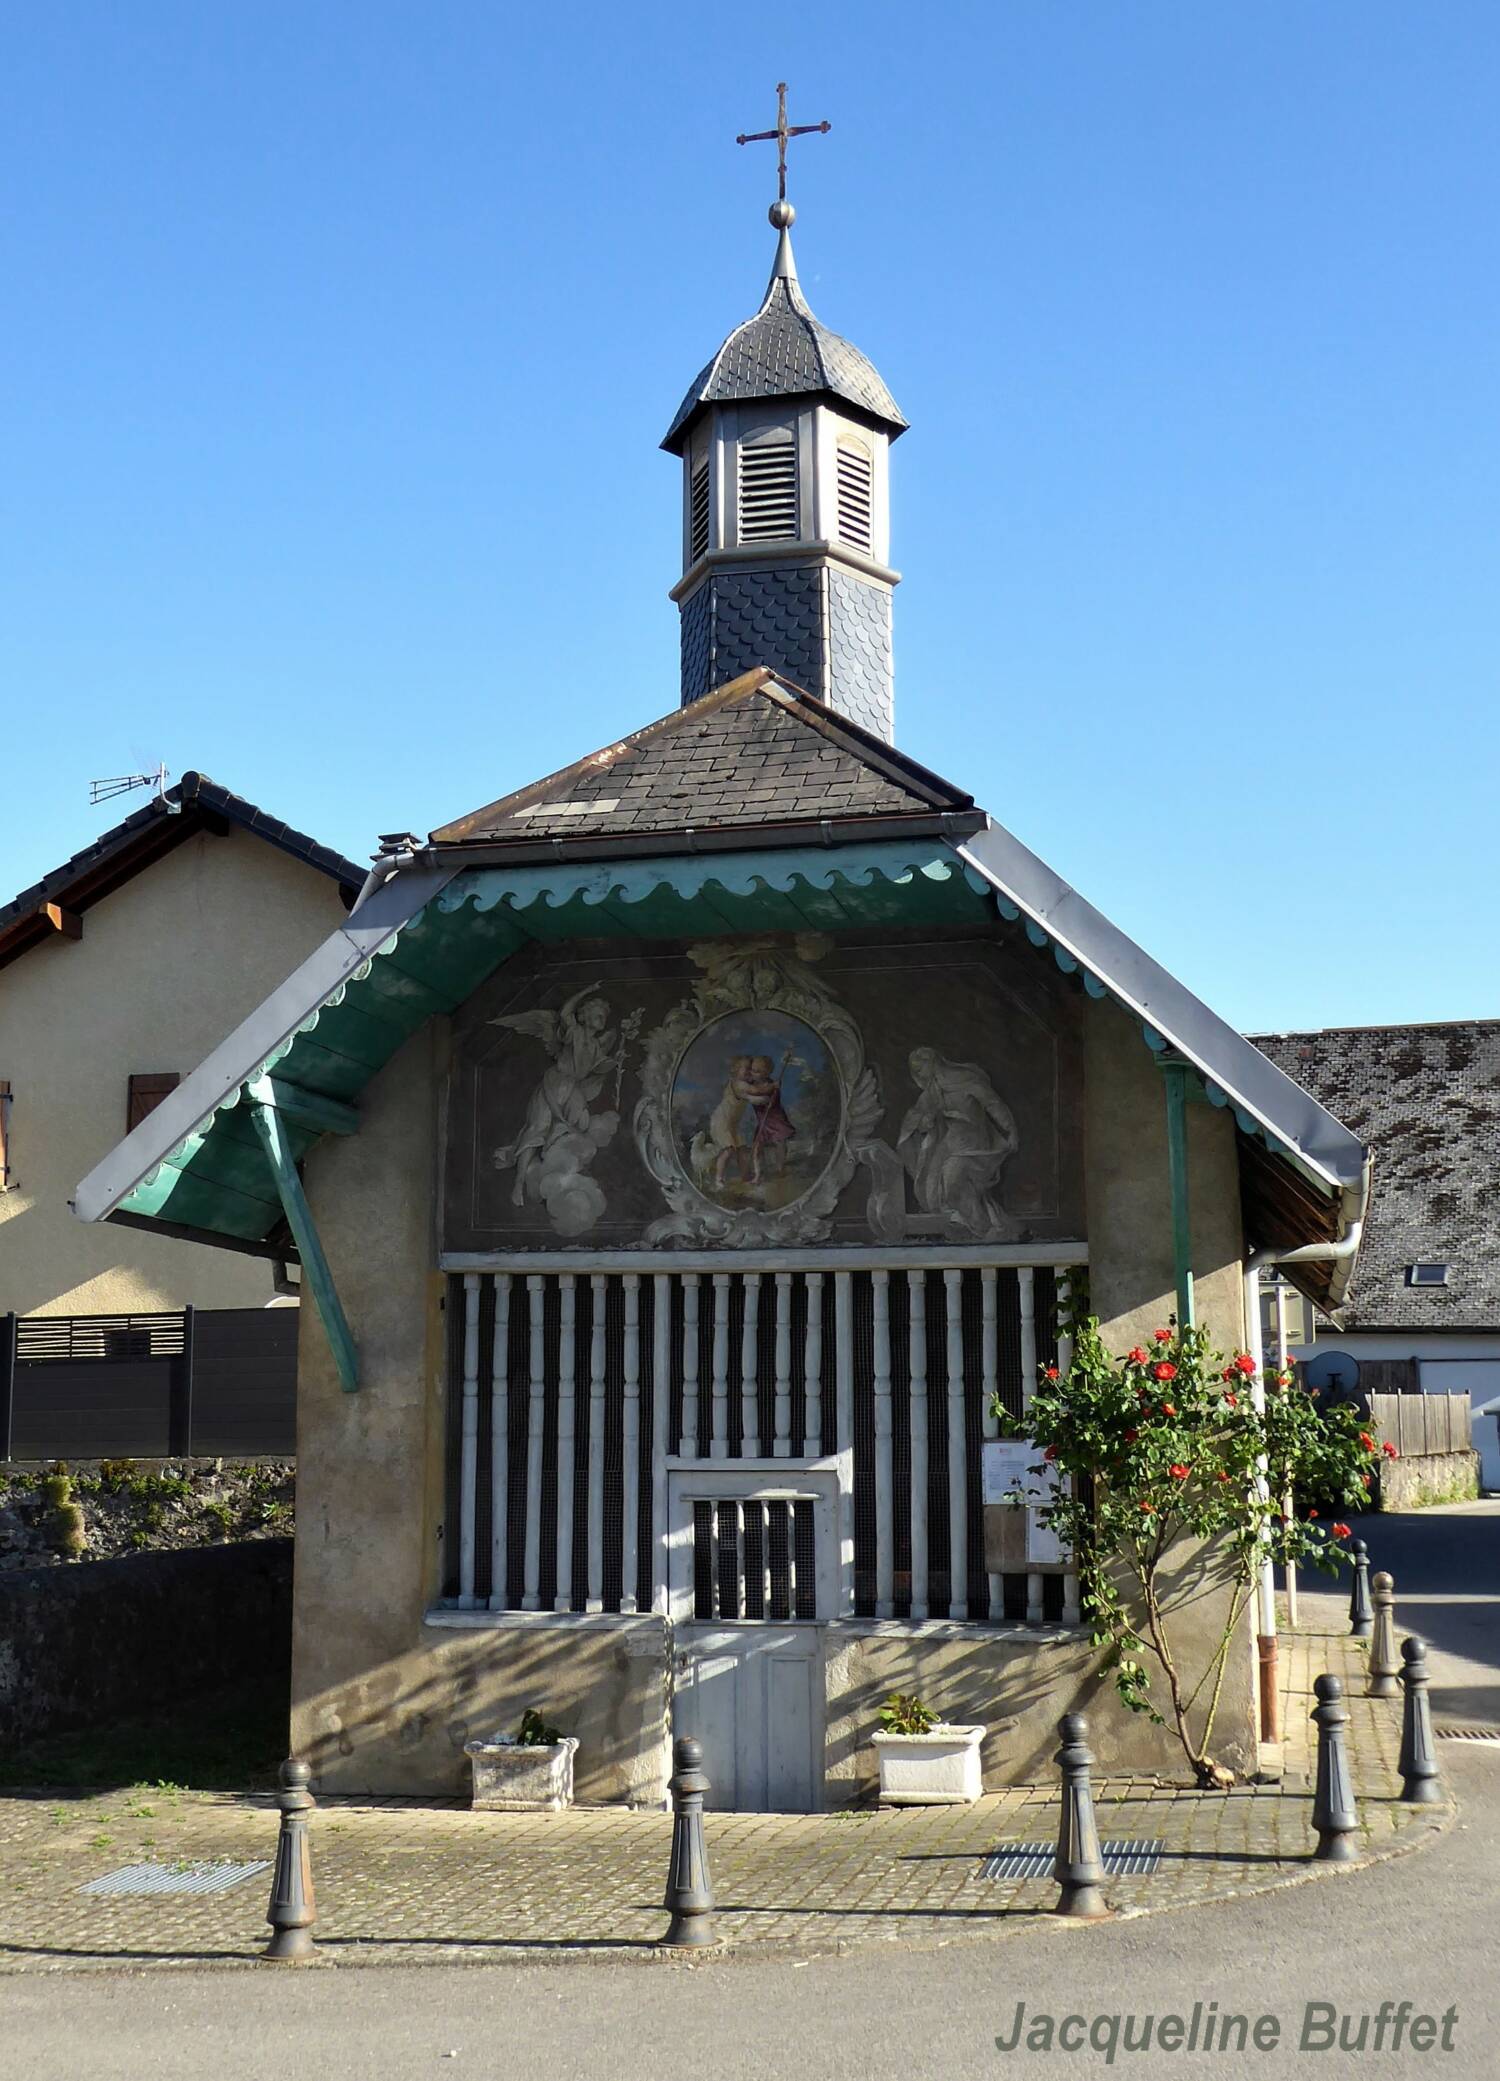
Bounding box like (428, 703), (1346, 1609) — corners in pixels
(1255, 1020), (1500, 1488)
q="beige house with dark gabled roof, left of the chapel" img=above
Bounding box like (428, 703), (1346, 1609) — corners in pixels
(0, 772), (364, 1315)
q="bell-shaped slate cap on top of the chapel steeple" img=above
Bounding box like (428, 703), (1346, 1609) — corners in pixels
(662, 233), (907, 452)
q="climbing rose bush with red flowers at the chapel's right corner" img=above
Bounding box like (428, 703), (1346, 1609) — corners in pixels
(994, 1315), (1392, 1785)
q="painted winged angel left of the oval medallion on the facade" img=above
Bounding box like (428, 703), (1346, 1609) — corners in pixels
(489, 984), (641, 1236)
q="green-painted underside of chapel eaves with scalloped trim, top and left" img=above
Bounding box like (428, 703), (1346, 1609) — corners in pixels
(121, 841), (994, 1244)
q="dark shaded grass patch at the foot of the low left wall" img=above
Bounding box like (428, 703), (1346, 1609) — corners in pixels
(0, 1688), (287, 1819)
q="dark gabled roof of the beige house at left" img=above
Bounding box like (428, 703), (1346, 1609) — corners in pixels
(0, 772), (364, 966)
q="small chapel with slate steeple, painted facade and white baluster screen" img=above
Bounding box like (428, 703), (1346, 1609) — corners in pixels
(77, 204), (1365, 1808)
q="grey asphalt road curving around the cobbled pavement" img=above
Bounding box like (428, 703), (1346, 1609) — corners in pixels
(0, 1511), (1500, 2081)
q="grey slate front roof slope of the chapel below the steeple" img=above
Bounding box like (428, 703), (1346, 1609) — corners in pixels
(433, 670), (974, 847)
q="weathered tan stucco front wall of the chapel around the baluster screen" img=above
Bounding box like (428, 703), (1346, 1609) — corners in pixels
(291, 953), (1255, 1804)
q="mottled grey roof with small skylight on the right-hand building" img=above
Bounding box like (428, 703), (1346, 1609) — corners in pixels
(1252, 1020), (1500, 1330)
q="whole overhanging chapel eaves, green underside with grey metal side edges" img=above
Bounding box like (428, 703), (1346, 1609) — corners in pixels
(75, 816), (1369, 1307)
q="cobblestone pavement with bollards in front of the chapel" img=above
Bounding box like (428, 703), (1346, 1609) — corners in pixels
(0, 1604), (1448, 1973)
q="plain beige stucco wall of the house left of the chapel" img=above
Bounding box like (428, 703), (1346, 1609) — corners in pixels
(0, 830), (343, 1315)
